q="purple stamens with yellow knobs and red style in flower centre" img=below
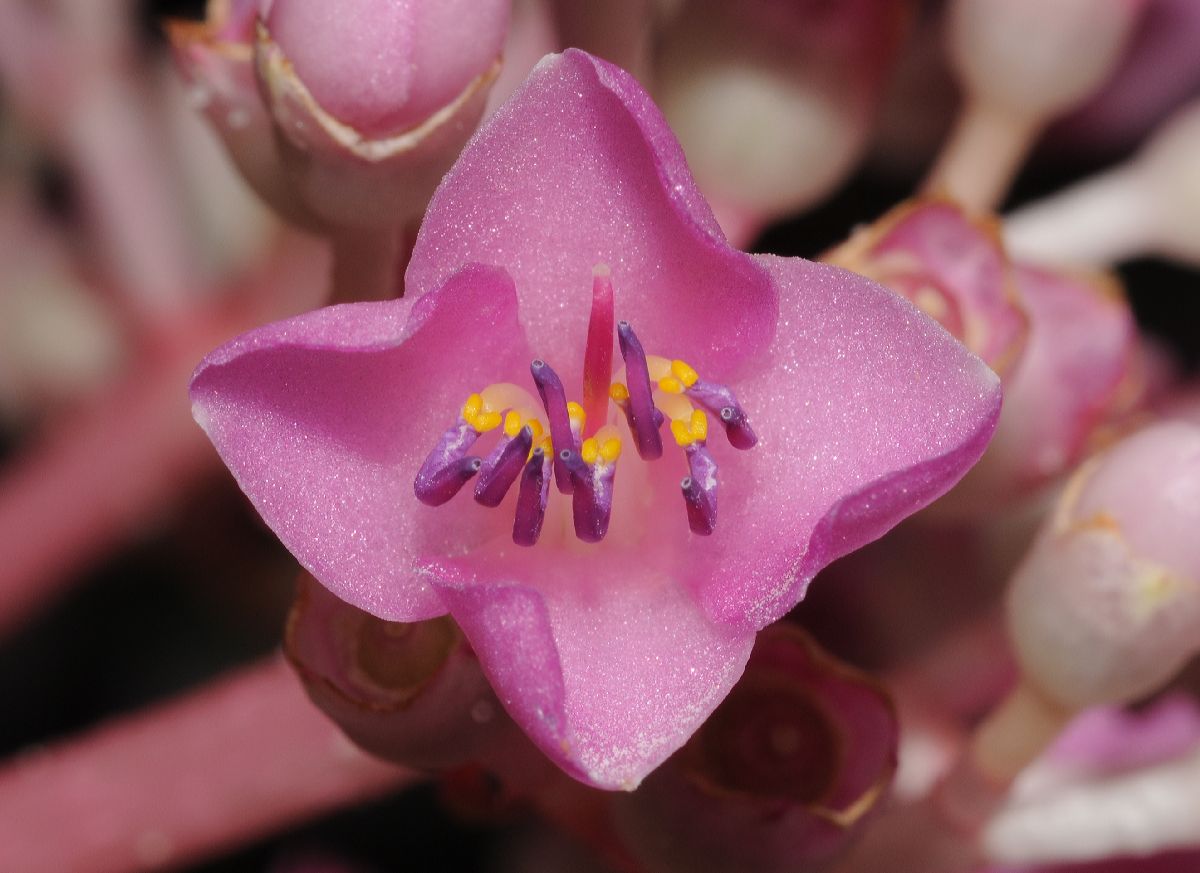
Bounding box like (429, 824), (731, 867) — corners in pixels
(414, 266), (757, 546)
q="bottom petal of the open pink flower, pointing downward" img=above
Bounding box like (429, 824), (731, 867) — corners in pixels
(434, 547), (754, 789)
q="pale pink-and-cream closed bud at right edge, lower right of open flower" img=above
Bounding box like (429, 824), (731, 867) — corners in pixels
(1008, 423), (1200, 709)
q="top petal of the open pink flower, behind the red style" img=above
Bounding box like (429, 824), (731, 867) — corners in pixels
(406, 50), (776, 385)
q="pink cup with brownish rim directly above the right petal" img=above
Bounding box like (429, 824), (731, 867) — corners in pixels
(822, 198), (1028, 375)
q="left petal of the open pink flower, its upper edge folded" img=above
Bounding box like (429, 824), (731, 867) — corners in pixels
(191, 266), (529, 621)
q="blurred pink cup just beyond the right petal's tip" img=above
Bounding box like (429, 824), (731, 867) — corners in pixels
(941, 266), (1142, 512)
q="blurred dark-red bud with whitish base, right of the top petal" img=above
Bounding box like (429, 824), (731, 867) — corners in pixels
(654, 0), (906, 245)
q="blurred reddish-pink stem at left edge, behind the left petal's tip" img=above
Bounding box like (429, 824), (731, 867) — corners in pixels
(0, 237), (324, 633)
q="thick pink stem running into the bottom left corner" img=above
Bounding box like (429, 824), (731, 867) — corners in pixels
(0, 658), (416, 873)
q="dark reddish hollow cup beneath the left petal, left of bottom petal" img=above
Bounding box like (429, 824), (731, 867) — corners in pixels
(284, 573), (510, 769)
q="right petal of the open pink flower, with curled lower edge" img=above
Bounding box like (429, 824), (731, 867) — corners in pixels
(688, 255), (1001, 627)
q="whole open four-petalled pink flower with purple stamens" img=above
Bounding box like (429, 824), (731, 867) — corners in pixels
(192, 52), (1000, 788)
